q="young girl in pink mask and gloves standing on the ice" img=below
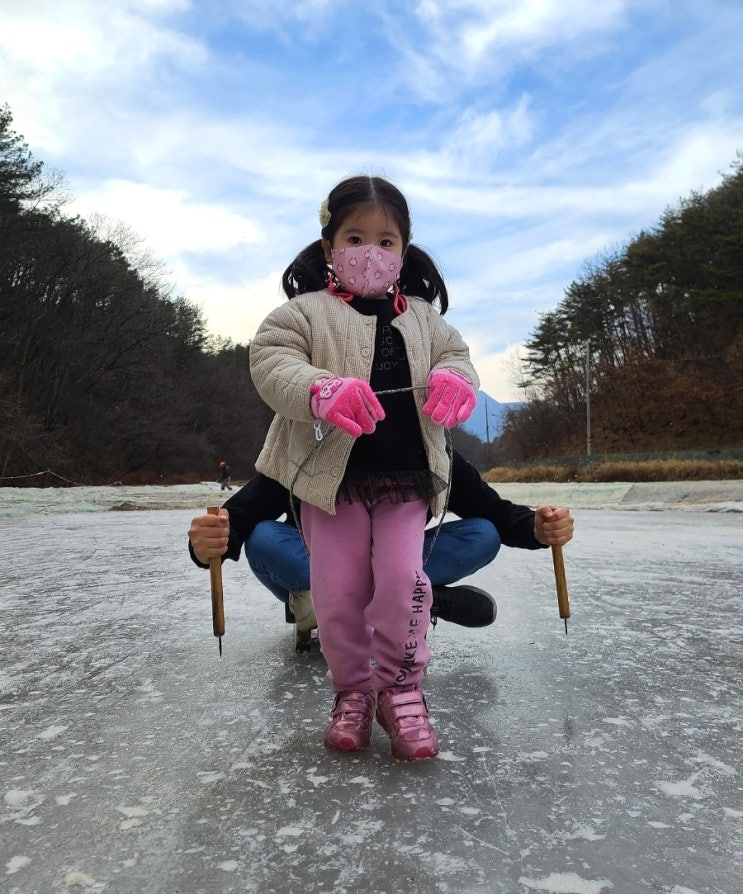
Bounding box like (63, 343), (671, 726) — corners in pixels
(250, 177), (479, 761)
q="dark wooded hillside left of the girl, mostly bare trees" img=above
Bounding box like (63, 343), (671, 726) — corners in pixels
(0, 107), (271, 485)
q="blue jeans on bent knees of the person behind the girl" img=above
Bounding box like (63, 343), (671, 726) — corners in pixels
(245, 518), (500, 602)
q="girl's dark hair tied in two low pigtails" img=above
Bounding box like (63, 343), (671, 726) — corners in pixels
(281, 176), (449, 316)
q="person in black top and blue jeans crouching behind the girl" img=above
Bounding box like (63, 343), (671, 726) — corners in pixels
(188, 450), (574, 651)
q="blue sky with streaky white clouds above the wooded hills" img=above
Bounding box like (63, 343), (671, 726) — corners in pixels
(0, 0), (743, 401)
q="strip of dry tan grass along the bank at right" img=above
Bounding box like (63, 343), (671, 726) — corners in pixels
(483, 459), (743, 484)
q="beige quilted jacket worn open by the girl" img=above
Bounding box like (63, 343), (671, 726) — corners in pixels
(250, 290), (479, 515)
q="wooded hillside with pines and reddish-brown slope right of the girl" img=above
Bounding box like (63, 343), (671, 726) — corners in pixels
(497, 152), (743, 461)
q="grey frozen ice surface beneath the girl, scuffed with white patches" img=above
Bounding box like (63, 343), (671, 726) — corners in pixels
(0, 496), (743, 894)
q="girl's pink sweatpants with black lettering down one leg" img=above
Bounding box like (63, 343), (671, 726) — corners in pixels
(302, 500), (432, 692)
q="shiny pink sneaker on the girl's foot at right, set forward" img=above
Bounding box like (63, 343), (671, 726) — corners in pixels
(377, 686), (439, 761)
